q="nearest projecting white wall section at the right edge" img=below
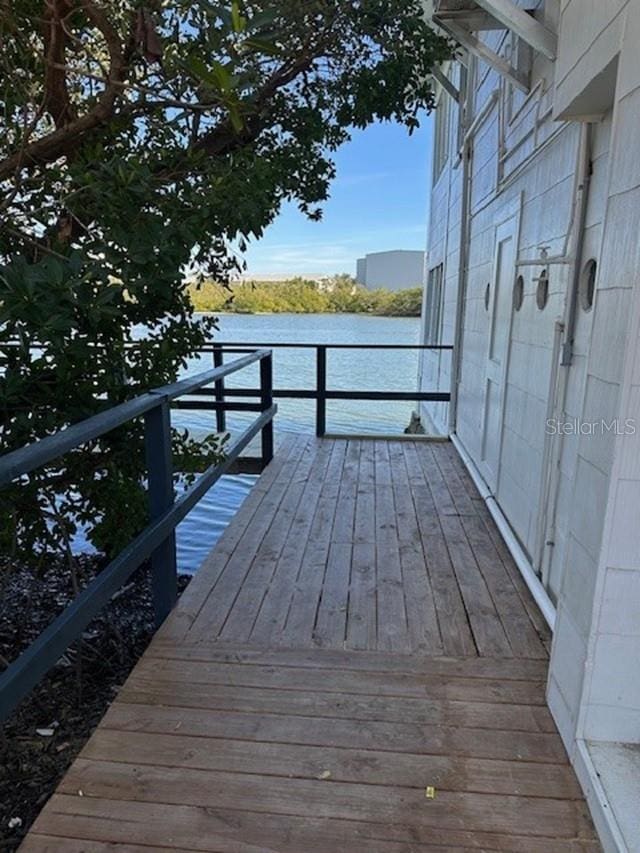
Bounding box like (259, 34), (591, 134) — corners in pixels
(550, 2), (640, 760)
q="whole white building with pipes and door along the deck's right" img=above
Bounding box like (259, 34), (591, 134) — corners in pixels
(421, 0), (640, 853)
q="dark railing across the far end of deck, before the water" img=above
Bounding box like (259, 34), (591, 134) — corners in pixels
(190, 341), (453, 438)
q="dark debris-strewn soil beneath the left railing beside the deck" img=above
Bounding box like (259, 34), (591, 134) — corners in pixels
(0, 558), (189, 851)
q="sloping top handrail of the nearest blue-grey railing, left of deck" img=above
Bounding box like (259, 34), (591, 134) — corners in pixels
(0, 349), (269, 487)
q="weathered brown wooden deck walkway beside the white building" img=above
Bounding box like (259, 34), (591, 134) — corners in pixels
(23, 438), (600, 853)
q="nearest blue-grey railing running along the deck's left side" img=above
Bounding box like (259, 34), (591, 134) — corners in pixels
(0, 348), (277, 720)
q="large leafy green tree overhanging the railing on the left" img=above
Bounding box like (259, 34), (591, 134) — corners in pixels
(0, 0), (450, 564)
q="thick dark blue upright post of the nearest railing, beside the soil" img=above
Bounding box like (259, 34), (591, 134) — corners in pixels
(145, 399), (178, 626)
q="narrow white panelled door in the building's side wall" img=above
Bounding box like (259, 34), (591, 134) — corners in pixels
(481, 217), (518, 494)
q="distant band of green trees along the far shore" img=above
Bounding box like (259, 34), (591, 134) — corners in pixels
(187, 275), (422, 317)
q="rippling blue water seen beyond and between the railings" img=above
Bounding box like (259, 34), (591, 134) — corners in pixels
(172, 314), (420, 573)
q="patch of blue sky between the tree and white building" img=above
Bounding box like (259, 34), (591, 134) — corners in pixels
(245, 118), (433, 275)
